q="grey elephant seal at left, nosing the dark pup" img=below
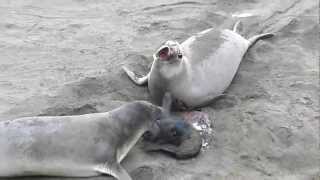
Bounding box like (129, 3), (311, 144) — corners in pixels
(0, 101), (171, 180)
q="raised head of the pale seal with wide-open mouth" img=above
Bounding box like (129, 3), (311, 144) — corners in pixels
(153, 41), (183, 64)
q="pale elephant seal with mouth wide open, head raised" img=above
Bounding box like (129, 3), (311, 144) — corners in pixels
(123, 22), (273, 109)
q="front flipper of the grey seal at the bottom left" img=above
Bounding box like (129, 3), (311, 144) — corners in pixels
(95, 163), (132, 180)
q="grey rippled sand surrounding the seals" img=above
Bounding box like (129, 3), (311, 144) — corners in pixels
(0, 0), (320, 180)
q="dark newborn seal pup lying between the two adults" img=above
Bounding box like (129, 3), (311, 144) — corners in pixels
(143, 93), (202, 159)
